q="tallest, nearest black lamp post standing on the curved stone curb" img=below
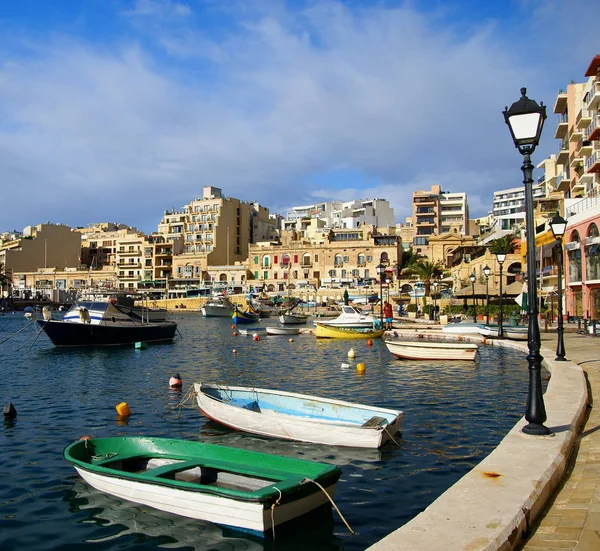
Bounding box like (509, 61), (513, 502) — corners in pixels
(502, 88), (551, 436)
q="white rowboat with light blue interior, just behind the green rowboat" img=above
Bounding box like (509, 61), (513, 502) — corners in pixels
(194, 383), (404, 448)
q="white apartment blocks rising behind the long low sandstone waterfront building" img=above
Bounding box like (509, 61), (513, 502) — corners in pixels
(281, 199), (396, 237)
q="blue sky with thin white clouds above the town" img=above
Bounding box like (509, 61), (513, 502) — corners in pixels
(0, 0), (600, 233)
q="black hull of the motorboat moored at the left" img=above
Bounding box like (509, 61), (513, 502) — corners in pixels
(38, 320), (177, 346)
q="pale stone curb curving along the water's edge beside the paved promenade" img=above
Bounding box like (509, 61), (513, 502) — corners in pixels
(368, 331), (588, 551)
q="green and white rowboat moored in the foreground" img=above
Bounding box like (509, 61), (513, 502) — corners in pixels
(63, 436), (341, 534)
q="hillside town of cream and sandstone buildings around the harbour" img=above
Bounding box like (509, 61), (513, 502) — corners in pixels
(0, 56), (600, 326)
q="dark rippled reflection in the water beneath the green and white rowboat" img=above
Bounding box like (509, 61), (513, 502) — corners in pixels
(66, 480), (337, 551)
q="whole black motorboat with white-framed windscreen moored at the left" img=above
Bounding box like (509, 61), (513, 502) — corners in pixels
(37, 301), (177, 346)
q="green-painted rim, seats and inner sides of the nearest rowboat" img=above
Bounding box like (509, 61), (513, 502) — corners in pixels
(63, 437), (341, 507)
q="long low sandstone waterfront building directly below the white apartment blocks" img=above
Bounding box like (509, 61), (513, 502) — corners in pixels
(248, 226), (402, 291)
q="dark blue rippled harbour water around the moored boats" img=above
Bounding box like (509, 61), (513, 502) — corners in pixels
(0, 313), (540, 551)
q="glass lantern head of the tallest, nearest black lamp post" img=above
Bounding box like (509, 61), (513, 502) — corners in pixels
(502, 88), (546, 155)
